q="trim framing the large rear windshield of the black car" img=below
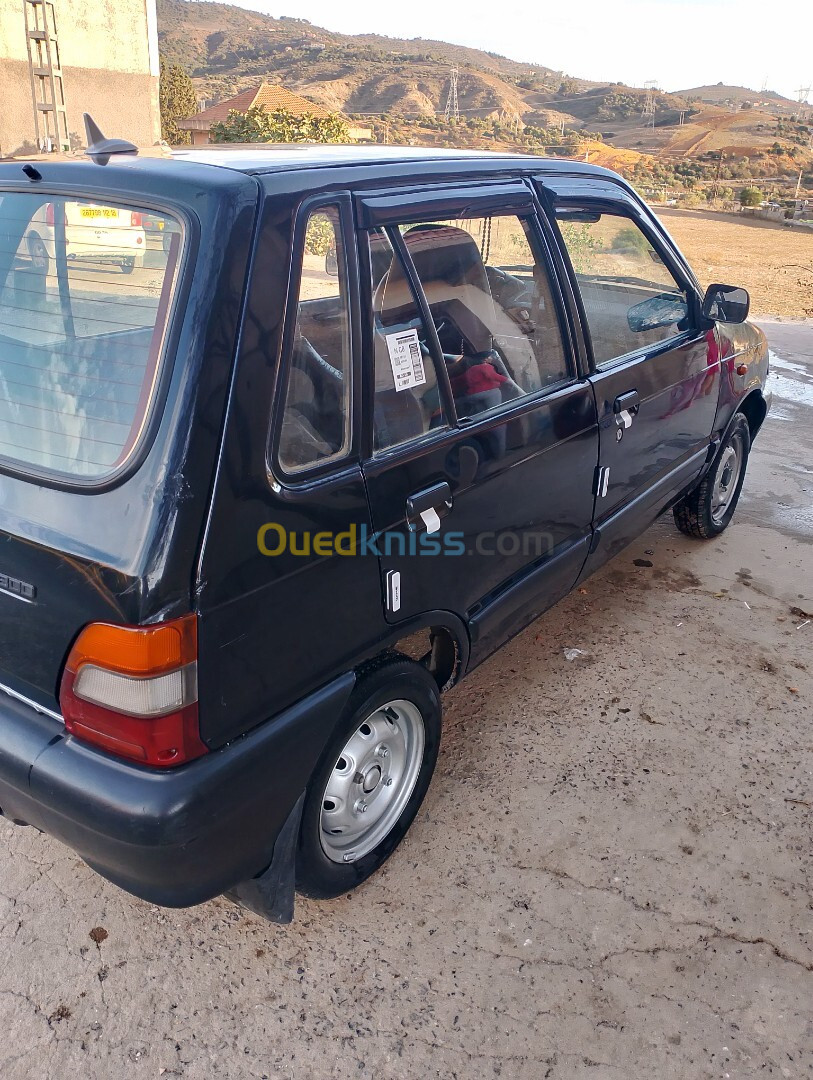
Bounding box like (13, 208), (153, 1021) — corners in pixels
(0, 184), (193, 495)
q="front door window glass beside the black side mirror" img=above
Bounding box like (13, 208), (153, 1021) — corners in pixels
(556, 207), (691, 368)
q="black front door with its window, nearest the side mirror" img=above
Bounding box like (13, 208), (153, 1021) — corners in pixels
(546, 184), (720, 572)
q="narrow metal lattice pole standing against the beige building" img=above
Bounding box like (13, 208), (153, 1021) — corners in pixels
(23, 0), (70, 153)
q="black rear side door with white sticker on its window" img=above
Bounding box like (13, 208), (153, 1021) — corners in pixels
(358, 181), (598, 662)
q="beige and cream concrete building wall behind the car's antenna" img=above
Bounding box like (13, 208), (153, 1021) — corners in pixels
(0, 0), (161, 157)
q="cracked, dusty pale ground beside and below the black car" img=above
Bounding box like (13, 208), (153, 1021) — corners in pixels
(0, 323), (813, 1080)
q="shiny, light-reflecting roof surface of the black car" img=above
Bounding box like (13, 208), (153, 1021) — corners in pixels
(172, 143), (614, 176)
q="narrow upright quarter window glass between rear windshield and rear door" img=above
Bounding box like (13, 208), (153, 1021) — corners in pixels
(279, 206), (351, 473)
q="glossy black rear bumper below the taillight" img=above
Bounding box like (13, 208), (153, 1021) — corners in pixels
(0, 674), (354, 907)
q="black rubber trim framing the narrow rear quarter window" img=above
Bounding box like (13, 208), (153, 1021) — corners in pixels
(266, 191), (361, 489)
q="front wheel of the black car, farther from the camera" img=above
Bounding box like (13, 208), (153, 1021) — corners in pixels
(673, 413), (750, 540)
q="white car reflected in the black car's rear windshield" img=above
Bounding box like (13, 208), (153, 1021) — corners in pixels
(21, 200), (147, 273)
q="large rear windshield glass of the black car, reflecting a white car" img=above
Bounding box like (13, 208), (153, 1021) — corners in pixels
(0, 192), (182, 481)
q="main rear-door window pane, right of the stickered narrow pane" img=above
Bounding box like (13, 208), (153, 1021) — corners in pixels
(401, 215), (571, 419)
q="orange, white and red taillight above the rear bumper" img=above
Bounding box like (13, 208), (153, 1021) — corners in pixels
(59, 615), (207, 768)
